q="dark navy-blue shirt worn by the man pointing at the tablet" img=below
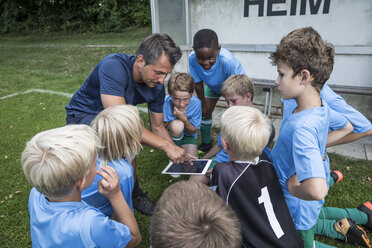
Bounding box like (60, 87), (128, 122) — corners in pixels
(66, 53), (165, 115)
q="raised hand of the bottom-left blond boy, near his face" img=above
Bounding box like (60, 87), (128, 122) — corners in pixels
(97, 166), (121, 199)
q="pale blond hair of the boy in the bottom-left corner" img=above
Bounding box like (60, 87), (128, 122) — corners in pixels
(21, 125), (101, 200)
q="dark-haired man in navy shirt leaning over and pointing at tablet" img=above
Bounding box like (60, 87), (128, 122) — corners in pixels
(66, 34), (190, 215)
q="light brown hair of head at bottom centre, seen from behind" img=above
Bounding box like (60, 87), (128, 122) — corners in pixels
(150, 181), (241, 248)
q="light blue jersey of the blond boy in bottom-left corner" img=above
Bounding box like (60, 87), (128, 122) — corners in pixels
(28, 188), (132, 248)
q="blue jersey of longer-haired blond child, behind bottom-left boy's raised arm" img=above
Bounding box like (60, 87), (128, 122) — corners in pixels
(81, 157), (134, 217)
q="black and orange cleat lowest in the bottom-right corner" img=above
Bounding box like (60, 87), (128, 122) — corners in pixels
(335, 218), (372, 248)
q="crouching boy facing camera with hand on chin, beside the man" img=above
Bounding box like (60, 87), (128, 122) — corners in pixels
(163, 72), (202, 157)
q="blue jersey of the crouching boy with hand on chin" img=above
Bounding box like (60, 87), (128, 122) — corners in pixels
(163, 96), (202, 138)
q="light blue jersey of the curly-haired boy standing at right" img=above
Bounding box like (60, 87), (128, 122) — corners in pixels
(270, 104), (330, 230)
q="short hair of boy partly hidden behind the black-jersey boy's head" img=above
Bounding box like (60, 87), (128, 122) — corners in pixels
(221, 74), (254, 101)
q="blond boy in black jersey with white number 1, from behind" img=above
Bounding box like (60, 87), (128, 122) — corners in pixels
(210, 106), (303, 248)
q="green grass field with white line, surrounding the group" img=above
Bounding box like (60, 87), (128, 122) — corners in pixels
(0, 28), (372, 247)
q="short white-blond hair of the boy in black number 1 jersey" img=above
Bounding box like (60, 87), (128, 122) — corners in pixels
(221, 106), (271, 160)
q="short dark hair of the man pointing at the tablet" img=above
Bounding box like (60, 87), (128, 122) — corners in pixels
(136, 34), (182, 66)
